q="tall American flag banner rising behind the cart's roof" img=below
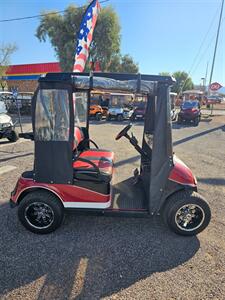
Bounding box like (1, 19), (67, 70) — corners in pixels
(73, 0), (100, 72)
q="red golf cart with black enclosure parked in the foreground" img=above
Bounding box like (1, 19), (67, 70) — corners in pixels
(10, 72), (211, 235)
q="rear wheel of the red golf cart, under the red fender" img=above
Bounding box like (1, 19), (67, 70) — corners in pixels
(18, 191), (64, 234)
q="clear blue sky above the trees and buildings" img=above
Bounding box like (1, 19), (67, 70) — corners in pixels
(0, 0), (225, 85)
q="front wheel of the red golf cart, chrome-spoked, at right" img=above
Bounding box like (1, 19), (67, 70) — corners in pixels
(163, 191), (211, 236)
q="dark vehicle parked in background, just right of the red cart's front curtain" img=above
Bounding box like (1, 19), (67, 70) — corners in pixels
(177, 101), (201, 126)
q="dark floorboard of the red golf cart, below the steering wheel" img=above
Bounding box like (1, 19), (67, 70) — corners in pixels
(110, 178), (147, 210)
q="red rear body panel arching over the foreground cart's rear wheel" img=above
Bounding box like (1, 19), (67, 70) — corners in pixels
(11, 177), (110, 203)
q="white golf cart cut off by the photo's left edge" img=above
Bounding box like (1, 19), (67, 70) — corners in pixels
(0, 100), (19, 142)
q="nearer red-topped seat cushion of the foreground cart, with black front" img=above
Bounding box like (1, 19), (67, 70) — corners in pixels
(73, 160), (113, 182)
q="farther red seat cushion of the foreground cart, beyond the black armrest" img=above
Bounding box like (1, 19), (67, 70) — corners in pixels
(79, 149), (115, 163)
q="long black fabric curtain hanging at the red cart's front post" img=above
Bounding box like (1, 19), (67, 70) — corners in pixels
(149, 83), (173, 215)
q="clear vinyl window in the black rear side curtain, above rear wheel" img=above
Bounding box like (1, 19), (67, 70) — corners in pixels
(35, 89), (70, 141)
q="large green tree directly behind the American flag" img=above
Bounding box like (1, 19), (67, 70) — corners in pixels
(36, 5), (120, 71)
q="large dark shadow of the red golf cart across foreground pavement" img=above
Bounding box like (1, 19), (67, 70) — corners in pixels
(0, 200), (200, 300)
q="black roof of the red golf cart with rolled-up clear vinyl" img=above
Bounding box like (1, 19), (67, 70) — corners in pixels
(39, 72), (175, 95)
